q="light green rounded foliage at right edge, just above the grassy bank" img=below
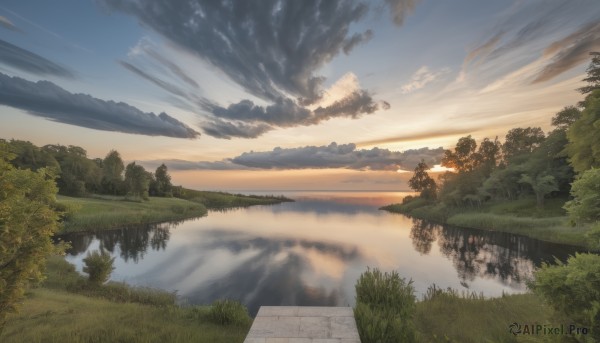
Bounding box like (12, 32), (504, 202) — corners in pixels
(565, 168), (600, 223)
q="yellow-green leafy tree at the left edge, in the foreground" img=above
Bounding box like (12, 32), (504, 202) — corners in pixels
(0, 143), (59, 331)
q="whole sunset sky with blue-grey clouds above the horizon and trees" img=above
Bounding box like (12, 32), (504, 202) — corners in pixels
(0, 0), (600, 191)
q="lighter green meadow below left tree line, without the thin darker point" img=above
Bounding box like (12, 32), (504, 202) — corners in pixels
(57, 195), (207, 233)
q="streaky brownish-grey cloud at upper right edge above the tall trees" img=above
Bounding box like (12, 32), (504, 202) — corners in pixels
(532, 22), (600, 84)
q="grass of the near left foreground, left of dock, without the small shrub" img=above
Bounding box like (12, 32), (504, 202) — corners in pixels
(1, 288), (249, 343)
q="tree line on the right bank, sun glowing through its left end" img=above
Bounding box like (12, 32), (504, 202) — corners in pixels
(409, 52), (600, 222)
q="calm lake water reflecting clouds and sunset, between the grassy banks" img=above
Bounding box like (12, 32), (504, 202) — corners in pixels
(65, 192), (575, 314)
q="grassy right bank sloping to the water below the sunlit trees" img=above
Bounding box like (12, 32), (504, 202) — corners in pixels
(380, 197), (597, 250)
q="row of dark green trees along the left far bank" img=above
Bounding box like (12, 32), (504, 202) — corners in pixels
(0, 139), (182, 199)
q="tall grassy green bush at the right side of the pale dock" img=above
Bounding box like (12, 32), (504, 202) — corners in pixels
(354, 268), (416, 343)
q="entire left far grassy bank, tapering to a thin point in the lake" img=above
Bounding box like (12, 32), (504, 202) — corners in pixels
(57, 189), (293, 233)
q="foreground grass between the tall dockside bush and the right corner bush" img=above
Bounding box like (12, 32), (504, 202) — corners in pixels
(414, 288), (571, 343)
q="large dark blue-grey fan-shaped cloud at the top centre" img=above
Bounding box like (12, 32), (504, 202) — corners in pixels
(102, 0), (370, 101)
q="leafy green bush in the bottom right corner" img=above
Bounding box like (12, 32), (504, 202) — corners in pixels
(529, 254), (600, 339)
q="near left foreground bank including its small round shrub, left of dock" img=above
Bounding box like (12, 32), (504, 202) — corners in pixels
(0, 256), (250, 343)
